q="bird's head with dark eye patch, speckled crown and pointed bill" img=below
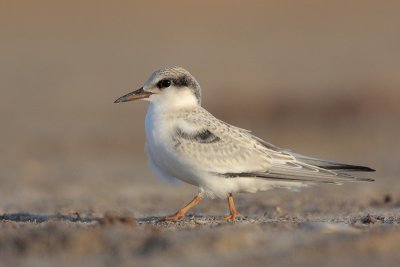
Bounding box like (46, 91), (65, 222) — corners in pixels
(114, 67), (201, 108)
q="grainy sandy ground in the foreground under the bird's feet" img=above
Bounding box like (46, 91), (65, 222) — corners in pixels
(0, 193), (400, 266)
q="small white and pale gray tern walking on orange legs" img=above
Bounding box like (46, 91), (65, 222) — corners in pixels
(115, 67), (375, 221)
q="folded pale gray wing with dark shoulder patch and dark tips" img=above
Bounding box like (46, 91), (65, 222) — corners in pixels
(174, 109), (372, 183)
